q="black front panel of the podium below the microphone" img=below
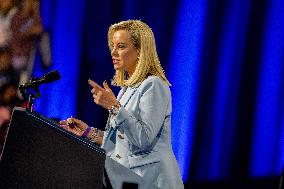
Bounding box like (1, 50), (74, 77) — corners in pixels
(0, 107), (106, 189)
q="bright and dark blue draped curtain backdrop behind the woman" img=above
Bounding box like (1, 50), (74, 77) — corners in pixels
(34, 0), (284, 186)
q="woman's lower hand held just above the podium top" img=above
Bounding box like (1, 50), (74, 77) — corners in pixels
(59, 117), (89, 137)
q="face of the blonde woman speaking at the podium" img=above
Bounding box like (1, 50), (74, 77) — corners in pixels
(111, 30), (139, 75)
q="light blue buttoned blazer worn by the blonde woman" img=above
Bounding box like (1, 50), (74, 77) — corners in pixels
(102, 76), (184, 189)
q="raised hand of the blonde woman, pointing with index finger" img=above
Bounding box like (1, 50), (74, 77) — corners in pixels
(88, 79), (119, 109)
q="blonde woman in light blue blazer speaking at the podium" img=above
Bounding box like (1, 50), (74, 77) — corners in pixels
(60, 20), (183, 189)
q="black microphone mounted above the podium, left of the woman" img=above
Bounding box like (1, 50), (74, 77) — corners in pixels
(19, 70), (60, 90)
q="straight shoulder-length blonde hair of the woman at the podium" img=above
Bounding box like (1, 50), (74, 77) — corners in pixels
(108, 20), (171, 87)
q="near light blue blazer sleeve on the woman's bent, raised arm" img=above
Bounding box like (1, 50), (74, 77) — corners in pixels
(111, 77), (171, 148)
